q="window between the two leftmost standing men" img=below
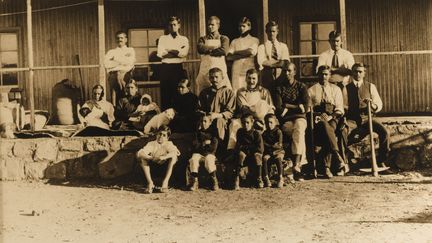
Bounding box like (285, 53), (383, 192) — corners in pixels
(128, 28), (164, 81)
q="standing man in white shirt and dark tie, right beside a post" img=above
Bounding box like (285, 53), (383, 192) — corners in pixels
(257, 21), (290, 91)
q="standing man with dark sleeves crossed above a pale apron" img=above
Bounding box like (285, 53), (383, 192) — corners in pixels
(194, 16), (231, 94)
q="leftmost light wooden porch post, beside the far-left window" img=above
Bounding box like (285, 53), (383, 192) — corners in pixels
(27, 0), (35, 131)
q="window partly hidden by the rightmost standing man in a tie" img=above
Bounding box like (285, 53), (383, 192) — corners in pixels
(299, 21), (336, 78)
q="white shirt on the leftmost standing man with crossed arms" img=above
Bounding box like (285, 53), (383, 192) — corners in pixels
(104, 46), (136, 72)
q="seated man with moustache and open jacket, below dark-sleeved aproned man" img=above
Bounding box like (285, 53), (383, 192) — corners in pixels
(199, 68), (236, 141)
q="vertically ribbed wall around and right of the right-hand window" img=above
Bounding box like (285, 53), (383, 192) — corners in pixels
(269, 0), (432, 113)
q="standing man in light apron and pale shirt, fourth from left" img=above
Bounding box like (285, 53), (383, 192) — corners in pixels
(227, 17), (259, 91)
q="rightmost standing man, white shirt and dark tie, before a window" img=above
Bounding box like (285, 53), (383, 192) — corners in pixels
(317, 30), (354, 85)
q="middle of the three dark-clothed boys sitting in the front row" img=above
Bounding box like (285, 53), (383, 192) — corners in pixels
(234, 114), (264, 190)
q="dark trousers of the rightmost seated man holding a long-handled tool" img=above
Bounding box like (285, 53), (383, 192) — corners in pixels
(342, 120), (390, 163)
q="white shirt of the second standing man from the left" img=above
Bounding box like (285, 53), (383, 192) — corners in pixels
(157, 34), (189, 63)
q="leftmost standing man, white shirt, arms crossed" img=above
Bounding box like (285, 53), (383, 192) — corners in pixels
(104, 31), (136, 106)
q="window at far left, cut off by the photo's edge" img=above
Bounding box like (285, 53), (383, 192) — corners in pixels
(0, 32), (19, 86)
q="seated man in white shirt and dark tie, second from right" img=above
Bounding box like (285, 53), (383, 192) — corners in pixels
(308, 65), (345, 178)
